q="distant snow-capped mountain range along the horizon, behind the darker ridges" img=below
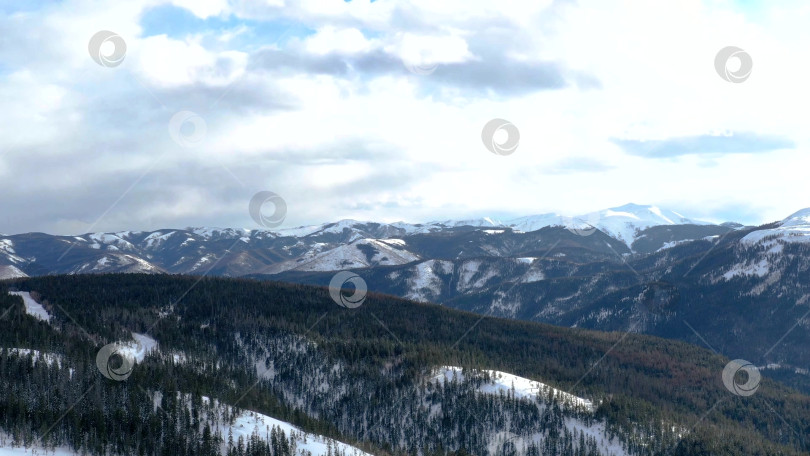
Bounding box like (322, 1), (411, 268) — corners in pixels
(0, 204), (796, 279)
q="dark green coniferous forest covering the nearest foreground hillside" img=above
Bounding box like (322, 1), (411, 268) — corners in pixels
(0, 274), (810, 456)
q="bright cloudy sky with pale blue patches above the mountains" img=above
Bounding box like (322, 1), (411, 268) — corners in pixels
(0, 0), (810, 234)
